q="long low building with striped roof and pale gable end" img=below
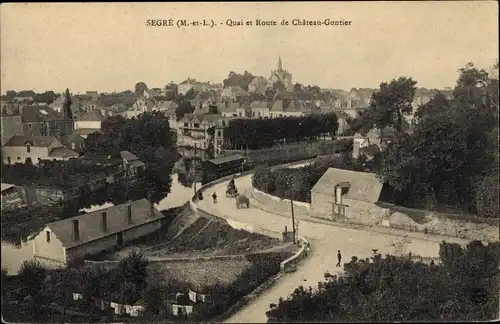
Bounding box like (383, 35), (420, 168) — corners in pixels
(31, 198), (164, 267)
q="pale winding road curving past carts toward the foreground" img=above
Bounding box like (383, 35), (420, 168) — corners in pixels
(196, 175), (464, 323)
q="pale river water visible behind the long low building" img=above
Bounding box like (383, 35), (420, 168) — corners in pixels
(1, 173), (201, 275)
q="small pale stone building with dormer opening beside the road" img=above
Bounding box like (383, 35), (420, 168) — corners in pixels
(310, 168), (385, 225)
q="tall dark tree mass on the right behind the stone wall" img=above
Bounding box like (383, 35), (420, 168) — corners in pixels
(378, 64), (498, 217)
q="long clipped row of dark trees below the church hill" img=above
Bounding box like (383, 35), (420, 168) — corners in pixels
(224, 113), (338, 149)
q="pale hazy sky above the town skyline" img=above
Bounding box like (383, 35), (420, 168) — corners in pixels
(0, 1), (499, 93)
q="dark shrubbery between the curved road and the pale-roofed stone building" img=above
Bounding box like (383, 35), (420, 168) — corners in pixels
(252, 152), (366, 202)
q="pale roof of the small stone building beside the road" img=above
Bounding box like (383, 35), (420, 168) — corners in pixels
(311, 168), (382, 203)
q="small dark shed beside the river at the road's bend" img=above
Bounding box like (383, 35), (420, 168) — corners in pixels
(203, 154), (245, 183)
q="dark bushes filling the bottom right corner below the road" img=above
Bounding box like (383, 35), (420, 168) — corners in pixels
(266, 242), (500, 323)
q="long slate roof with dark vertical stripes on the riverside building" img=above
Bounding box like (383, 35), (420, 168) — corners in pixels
(45, 198), (163, 249)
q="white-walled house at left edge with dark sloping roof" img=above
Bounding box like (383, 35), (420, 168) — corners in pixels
(2, 135), (78, 164)
